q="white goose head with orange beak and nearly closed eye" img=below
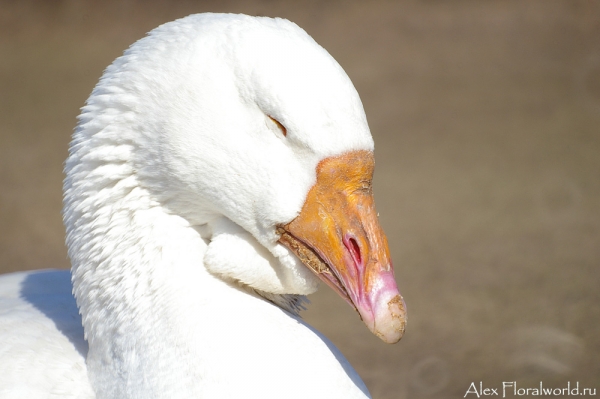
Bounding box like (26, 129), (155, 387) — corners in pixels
(64, 14), (406, 343)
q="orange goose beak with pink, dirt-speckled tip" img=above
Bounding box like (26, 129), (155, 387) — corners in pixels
(278, 151), (406, 343)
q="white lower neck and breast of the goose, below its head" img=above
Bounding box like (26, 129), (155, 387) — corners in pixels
(73, 203), (367, 399)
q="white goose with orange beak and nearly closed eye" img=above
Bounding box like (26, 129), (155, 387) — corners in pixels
(0, 14), (406, 399)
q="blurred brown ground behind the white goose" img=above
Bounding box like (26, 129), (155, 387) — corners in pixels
(0, 0), (600, 399)
